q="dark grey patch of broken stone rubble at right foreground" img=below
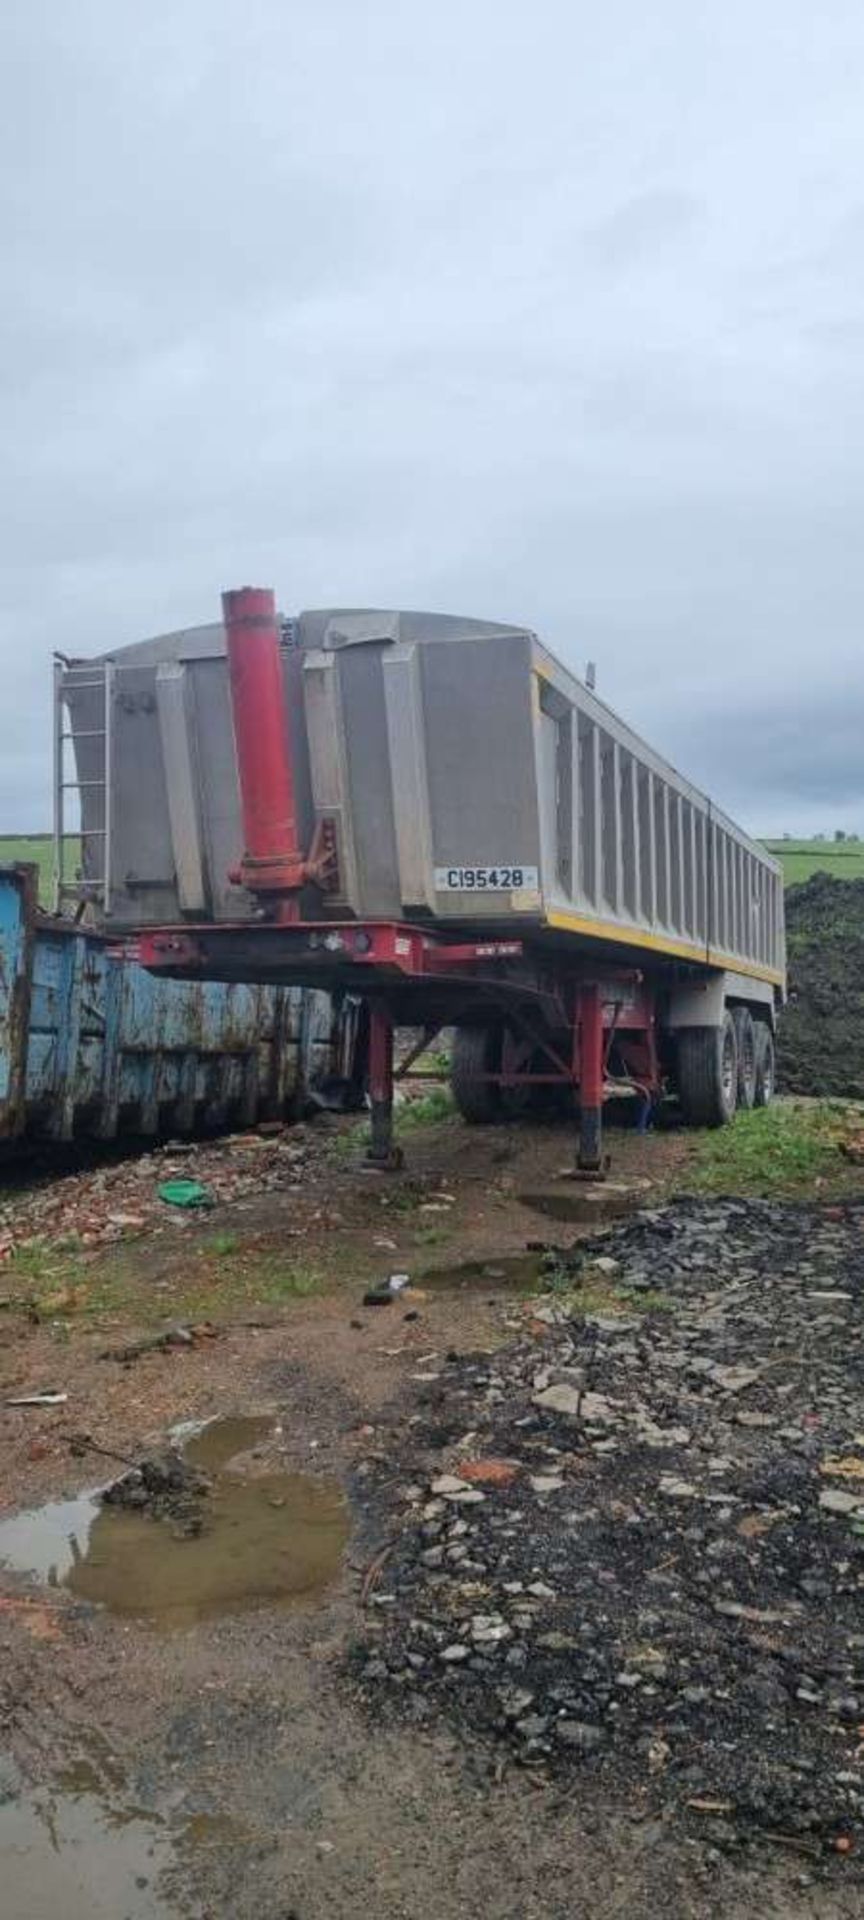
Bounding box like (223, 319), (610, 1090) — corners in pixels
(353, 1200), (864, 1872)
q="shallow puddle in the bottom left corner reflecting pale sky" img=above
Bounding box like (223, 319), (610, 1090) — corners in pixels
(0, 1730), (245, 1920)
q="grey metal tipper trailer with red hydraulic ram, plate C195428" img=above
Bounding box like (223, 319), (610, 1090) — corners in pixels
(56, 588), (785, 1173)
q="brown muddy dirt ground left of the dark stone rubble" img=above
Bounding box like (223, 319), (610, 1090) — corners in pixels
(0, 1121), (864, 1920)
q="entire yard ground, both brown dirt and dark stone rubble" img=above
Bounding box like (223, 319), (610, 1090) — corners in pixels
(0, 1108), (864, 1920)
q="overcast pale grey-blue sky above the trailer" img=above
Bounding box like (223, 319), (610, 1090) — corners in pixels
(0, 0), (864, 831)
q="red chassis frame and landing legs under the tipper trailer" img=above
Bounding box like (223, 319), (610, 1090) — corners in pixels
(138, 920), (660, 1173)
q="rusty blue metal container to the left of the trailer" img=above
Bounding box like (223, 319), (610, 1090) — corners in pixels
(0, 866), (344, 1142)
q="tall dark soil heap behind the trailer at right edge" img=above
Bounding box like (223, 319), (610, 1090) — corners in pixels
(778, 874), (864, 1100)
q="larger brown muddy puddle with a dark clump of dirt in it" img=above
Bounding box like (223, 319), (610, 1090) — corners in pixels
(0, 1421), (349, 1628)
